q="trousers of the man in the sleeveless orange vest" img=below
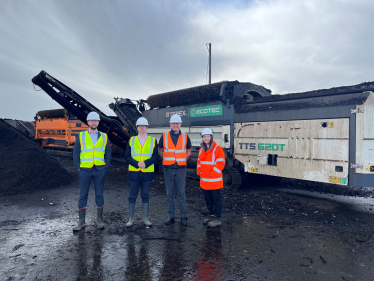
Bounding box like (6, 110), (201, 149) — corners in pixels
(164, 166), (187, 218)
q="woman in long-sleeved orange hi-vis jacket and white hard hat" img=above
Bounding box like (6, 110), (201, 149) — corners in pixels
(197, 128), (225, 227)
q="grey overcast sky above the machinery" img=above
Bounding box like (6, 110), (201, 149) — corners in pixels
(0, 0), (374, 120)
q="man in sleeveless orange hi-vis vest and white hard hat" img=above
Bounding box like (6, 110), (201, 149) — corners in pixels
(158, 114), (191, 226)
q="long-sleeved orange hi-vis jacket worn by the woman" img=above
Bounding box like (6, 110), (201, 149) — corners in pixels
(196, 140), (226, 190)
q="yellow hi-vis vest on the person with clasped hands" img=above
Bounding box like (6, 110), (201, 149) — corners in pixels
(129, 136), (156, 173)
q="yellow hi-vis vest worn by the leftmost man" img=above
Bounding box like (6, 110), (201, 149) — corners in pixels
(79, 131), (108, 168)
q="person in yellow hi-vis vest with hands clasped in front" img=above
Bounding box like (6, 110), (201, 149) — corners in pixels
(125, 117), (159, 227)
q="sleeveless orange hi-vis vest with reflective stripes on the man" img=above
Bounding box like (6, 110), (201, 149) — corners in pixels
(162, 131), (187, 166)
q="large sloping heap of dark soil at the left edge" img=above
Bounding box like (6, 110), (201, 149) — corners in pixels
(0, 120), (72, 194)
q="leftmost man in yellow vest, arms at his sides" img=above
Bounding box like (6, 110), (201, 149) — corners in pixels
(73, 112), (112, 231)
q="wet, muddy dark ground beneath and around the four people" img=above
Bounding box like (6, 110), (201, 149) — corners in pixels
(0, 158), (374, 280)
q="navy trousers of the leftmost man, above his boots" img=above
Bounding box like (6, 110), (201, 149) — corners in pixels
(78, 167), (106, 209)
